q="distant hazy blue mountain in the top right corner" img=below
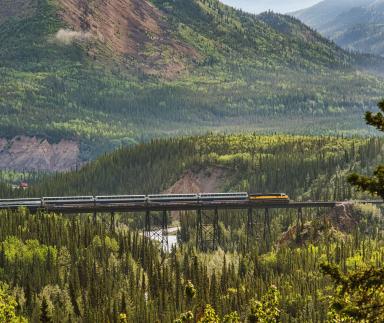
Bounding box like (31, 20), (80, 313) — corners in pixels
(293, 0), (384, 56)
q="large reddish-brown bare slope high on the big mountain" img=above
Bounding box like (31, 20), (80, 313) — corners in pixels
(59, 0), (198, 78)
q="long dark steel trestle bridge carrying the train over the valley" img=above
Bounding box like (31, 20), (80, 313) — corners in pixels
(0, 200), (384, 250)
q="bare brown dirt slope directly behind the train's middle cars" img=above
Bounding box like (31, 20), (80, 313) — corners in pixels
(164, 167), (227, 194)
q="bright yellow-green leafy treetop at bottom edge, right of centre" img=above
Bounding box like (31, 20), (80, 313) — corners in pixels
(247, 286), (280, 323)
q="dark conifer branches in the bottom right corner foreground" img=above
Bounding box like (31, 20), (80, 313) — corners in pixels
(321, 264), (384, 322)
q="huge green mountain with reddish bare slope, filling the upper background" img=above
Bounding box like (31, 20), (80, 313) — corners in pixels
(0, 0), (384, 169)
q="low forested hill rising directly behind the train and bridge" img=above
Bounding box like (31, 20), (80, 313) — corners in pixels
(18, 134), (383, 200)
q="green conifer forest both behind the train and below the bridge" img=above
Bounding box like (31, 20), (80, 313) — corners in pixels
(0, 134), (384, 322)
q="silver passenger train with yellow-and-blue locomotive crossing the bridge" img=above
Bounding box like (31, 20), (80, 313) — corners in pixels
(0, 192), (289, 208)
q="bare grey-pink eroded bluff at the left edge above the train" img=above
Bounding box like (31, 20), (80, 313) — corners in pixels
(0, 136), (80, 172)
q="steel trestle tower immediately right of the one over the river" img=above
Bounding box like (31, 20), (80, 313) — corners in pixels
(196, 208), (219, 251)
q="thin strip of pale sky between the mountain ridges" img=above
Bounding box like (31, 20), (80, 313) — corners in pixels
(221, 0), (320, 13)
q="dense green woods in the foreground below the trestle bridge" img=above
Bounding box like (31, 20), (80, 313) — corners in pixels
(0, 199), (384, 322)
